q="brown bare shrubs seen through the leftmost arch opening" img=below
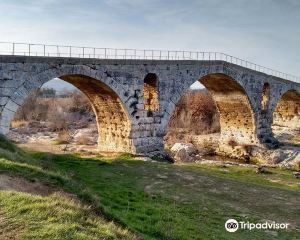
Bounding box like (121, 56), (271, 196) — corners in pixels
(11, 89), (95, 131)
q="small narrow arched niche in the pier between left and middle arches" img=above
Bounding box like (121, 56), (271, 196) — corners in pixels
(143, 73), (159, 111)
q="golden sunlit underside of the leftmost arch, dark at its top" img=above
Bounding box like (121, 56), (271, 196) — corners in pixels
(59, 74), (133, 153)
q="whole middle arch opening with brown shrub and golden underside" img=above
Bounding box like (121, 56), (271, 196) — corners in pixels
(165, 74), (258, 158)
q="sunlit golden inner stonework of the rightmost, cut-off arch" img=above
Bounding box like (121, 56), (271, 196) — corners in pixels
(273, 89), (300, 129)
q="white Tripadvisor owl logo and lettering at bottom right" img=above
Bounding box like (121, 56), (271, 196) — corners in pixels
(225, 219), (289, 232)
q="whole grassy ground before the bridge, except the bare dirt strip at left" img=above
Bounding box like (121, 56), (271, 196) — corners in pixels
(0, 137), (300, 240)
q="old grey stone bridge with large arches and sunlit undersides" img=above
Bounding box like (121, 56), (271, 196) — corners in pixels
(0, 55), (300, 154)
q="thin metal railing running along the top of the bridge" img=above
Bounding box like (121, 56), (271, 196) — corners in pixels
(0, 42), (300, 83)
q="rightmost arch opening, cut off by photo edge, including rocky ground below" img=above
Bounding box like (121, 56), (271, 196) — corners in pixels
(272, 90), (300, 144)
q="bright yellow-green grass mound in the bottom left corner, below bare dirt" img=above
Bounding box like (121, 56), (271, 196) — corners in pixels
(0, 191), (134, 240)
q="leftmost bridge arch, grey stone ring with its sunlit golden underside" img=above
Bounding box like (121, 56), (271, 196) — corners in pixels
(1, 66), (135, 153)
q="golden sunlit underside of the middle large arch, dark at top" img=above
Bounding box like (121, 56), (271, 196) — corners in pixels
(198, 73), (258, 145)
